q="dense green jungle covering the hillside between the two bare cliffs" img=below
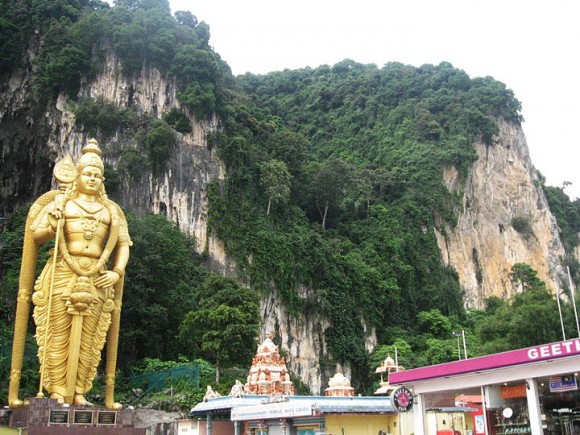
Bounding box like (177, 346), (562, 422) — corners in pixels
(203, 60), (521, 382)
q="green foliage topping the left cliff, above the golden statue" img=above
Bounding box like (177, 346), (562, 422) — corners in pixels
(0, 0), (231, 116)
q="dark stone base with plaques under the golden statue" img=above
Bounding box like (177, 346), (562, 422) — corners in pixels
(8, 398), (146, 435)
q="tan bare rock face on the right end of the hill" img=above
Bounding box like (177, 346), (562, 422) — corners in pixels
(435, 121), (564, 307)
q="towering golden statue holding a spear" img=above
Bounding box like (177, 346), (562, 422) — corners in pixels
(8, 139), (132, 409)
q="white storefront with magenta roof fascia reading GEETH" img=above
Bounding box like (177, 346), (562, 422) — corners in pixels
(390, 339), (580, 435)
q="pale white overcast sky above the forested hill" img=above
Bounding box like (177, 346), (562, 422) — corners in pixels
(170, 0), (580, 198)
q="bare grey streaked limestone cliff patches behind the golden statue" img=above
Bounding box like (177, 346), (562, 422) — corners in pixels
(0, 55), (229, 269)
